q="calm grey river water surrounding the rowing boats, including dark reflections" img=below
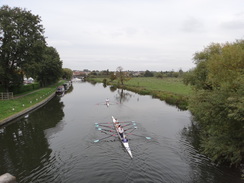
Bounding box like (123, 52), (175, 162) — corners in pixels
(0, 83), (242, 183)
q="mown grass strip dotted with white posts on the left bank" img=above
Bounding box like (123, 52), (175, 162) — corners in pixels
(0, 81), (63, 120)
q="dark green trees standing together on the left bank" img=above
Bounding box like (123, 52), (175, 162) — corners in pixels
(0, 6), (62, 92)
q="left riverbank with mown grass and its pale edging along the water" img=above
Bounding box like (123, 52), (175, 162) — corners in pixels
(0, 81), (64, 126)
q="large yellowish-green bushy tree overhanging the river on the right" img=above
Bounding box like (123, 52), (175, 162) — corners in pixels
(184, 40), (244, 165)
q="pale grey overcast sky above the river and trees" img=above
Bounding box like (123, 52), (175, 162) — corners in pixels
(0, 0), (244, 71)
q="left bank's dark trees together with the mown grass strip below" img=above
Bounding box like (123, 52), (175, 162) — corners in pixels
(0, 5), (72, 120)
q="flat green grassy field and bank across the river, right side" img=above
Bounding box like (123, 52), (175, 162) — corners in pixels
(86, 77), (192, 110)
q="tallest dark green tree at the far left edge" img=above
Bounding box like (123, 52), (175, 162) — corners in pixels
(0, 6), (45, 91)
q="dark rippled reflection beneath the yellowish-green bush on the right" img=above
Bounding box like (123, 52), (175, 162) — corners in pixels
(180, 119), (242, 183)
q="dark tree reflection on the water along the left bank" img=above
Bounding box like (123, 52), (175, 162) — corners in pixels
(0, 97), (64, 182)
